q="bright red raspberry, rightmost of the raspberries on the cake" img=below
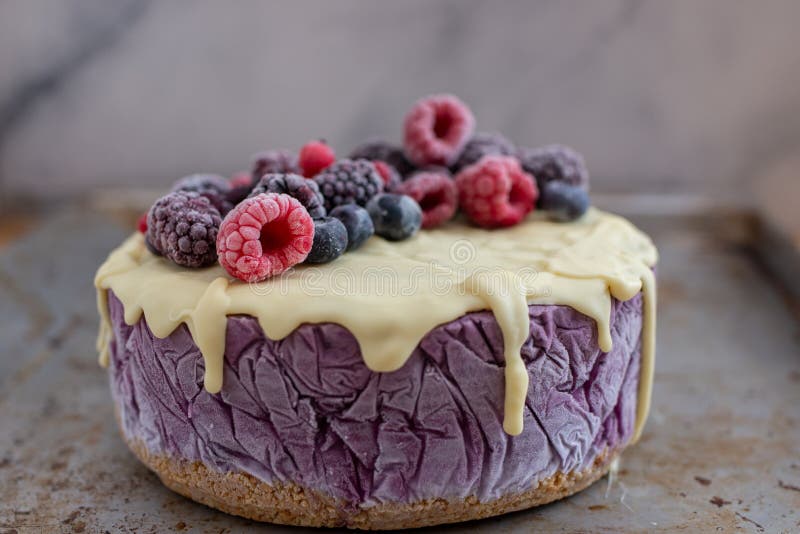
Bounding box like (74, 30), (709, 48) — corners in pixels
(455, 156), (539, 228)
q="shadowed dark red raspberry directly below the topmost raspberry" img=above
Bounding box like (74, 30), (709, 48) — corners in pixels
(397, 172), (458, 228)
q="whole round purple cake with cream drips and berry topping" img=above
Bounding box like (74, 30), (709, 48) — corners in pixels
(95, 95), (657, 529)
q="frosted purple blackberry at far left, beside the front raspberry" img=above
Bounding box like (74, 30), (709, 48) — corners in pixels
(145, 191), (222, 268)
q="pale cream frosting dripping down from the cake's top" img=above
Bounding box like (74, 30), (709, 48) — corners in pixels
(95, 209), (657, 440)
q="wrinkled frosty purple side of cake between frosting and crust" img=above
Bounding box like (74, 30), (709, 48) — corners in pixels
(108, 292), (642, 505)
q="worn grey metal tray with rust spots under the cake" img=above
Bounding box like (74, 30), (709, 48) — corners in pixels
(0, 213), (800, 533)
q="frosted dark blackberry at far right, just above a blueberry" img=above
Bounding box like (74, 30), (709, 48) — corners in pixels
(517, 145), (589, 193)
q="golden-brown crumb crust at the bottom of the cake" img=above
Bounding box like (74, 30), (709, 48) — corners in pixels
(126, 439), (622, 530)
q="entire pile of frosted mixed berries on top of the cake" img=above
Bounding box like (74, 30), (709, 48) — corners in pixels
(138, 94), (589, 282)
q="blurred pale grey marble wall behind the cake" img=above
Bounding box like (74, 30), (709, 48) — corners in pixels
(0, 0), (800, 206)
